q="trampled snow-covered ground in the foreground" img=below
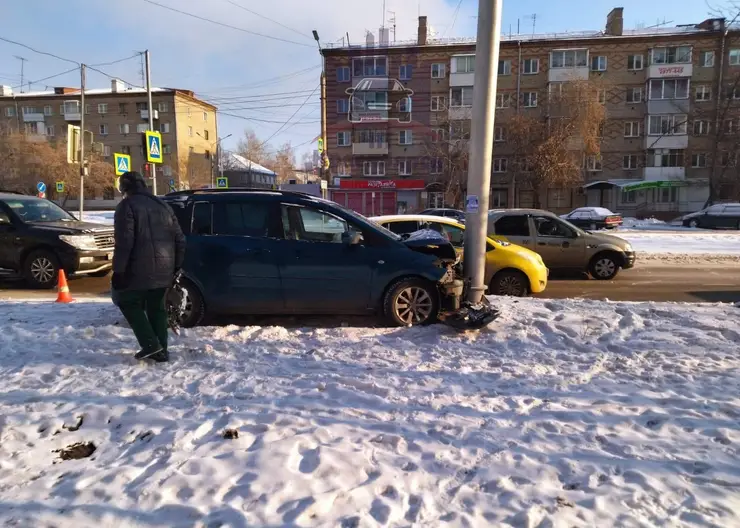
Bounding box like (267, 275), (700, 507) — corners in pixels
(0, 299), (740, 527)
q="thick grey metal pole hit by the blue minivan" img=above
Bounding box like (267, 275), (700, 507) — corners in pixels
(463, 0), (502, 303)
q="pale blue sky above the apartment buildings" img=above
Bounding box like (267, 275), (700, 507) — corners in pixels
(0, 0), (721, 161)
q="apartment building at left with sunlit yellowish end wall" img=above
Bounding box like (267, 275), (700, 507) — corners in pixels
(0, 79), (218, 194)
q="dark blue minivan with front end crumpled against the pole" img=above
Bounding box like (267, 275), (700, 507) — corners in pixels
(164, 189), (498, 330)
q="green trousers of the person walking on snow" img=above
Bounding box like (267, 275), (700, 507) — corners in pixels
(116, 288), (169, 350)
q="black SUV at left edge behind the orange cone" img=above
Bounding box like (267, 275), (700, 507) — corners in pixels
(0, 192), (114, 289)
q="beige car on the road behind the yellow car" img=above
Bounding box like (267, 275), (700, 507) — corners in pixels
(488, 209), (635, 280)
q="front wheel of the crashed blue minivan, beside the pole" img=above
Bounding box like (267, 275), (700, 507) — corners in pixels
(383, 278), (439, 326)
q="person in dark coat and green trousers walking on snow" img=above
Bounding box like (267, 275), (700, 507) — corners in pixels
(111, 172), (185, 362)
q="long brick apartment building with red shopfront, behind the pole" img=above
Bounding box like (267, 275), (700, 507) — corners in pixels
(322, 8), (740, 216)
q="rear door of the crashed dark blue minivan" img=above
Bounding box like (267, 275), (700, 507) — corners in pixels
(186, 198), (285, 314)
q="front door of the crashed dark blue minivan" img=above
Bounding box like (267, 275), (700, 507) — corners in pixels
(280, 203), (374, 314)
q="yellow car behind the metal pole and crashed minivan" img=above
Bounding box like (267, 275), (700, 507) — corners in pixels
(370, 215), (548, 297)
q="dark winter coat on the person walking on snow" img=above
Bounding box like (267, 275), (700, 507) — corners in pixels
(113, 173), (185, 290)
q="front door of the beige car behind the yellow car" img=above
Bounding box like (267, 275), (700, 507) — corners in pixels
(531, 215), (586, 269)
